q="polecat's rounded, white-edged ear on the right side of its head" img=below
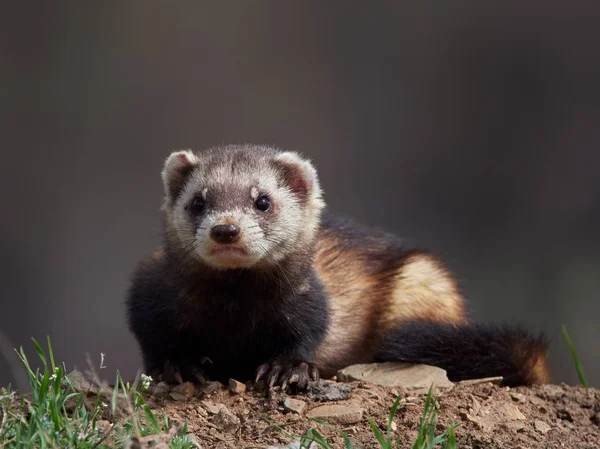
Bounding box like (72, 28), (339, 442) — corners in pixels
(275, 151), (321, 199)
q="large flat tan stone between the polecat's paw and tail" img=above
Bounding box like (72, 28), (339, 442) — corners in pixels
(338, 362), (454, 392)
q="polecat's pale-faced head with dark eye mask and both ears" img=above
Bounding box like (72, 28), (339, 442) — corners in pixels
(162, 146), (324, 269)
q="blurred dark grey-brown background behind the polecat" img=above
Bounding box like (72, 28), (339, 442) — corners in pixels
(0, 0), (600, 386)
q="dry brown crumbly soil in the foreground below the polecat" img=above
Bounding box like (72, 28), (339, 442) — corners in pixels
(145, 382), (600, 449)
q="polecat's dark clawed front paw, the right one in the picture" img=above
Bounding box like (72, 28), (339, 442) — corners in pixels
(255, 359), (319, 390)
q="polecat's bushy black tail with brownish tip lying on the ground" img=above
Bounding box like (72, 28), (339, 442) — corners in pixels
(377, 321), (550, 386)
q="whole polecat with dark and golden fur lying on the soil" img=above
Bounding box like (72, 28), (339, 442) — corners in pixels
(127, 145), (549, 388)
